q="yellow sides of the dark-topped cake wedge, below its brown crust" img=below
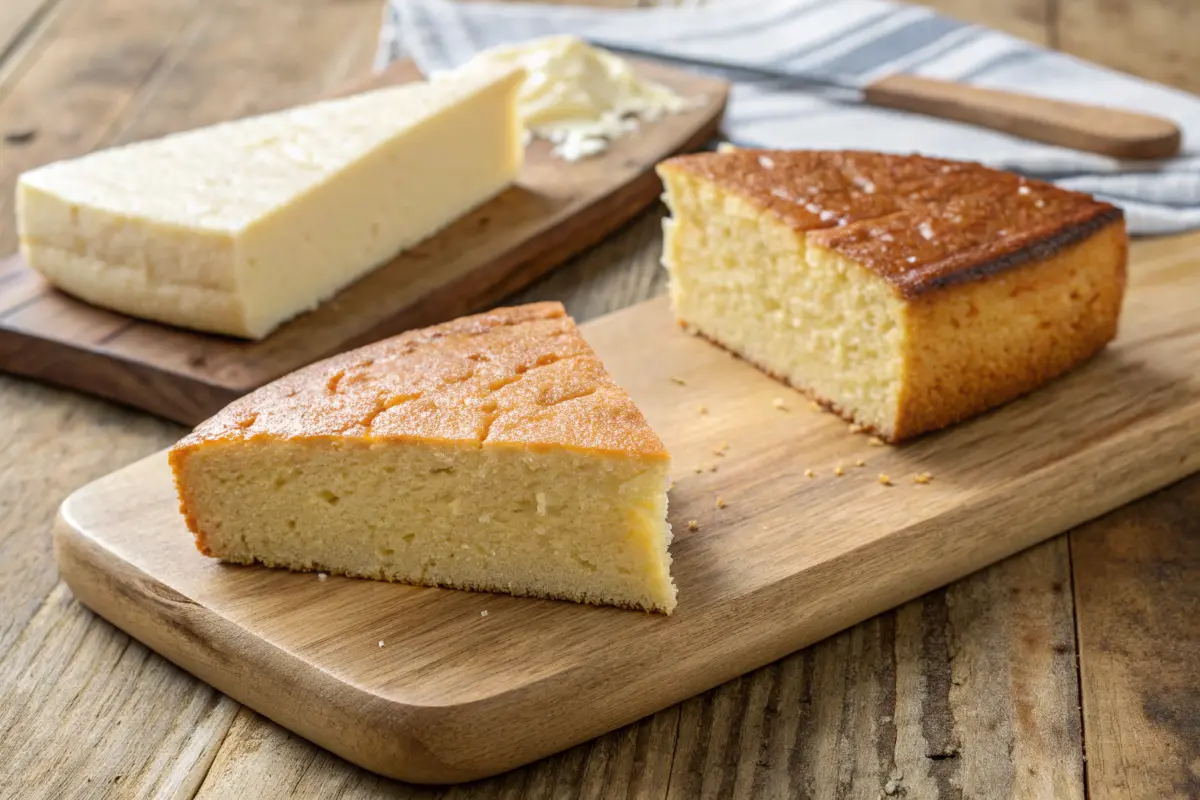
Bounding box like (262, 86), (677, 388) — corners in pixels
(659, 155), (1127, 443)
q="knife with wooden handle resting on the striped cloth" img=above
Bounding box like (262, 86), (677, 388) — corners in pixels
(589, 37), (1182, 160)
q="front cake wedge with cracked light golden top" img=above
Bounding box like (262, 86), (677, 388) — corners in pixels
(170, 302), (676, 613)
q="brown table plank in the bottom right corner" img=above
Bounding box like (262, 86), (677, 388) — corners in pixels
(1070, 476), (1200, 800)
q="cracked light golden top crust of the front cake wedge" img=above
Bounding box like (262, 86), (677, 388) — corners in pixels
(172, 302), (667, 455)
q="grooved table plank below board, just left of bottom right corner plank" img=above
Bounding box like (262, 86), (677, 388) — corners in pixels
(671, 539), (1084, 800)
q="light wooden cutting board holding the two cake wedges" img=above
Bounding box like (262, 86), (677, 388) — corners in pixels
(55, 237), (1200, 782)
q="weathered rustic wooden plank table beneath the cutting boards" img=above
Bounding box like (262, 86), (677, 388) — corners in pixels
(0, 0), (1200, 799)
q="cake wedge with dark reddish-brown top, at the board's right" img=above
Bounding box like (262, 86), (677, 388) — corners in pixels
(658, 150), (1127, 443)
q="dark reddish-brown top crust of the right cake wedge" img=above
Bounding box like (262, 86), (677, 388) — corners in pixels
(659, 150), (1122, 297)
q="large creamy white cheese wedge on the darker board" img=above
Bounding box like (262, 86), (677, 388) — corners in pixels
(17, 63), (523, 338)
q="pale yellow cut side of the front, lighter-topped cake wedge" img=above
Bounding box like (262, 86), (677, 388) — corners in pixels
(176, 443), (673, 608)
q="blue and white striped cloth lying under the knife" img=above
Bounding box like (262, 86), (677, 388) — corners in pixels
(377, 0), (1200, 234)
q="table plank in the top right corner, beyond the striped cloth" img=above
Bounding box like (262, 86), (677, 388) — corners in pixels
(1055, 0), (1200, 92)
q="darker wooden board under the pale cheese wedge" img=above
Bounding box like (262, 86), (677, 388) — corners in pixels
(0, 60), (728, 425)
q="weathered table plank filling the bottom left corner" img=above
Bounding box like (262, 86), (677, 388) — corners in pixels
(0, 584), (238, 798)
